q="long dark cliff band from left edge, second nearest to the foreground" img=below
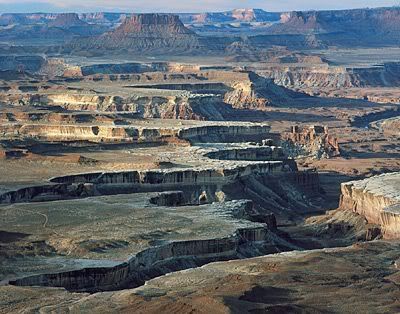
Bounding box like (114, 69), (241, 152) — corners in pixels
(0, 161), (297, 204)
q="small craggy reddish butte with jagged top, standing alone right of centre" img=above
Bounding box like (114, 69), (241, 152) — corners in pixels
(282, 125), (340, 159)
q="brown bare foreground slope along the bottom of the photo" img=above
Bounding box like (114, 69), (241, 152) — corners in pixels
(0, 241), (400, 313)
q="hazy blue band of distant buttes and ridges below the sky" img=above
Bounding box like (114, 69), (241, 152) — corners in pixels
(0, 7), (400, 54)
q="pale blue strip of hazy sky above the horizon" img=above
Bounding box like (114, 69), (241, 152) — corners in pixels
(0, 0), (400, 13)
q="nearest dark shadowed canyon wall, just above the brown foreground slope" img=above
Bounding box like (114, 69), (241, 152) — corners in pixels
(11, 222), (292, 292)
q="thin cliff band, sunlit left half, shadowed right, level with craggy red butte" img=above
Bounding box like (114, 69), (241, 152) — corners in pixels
(0, 120), (270, 143)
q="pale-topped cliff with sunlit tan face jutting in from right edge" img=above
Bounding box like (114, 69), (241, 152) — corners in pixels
(340, 172), (400, 239)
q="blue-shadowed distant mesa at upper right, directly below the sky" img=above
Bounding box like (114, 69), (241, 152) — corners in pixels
(269, 7), (400, 46)
